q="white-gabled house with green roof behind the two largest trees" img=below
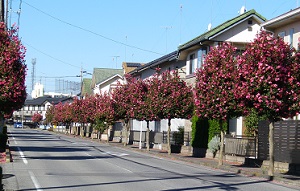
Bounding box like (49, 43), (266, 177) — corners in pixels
(178, 9), (266, 135)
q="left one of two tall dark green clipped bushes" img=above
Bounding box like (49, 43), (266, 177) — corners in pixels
(191, 115), (209, 149)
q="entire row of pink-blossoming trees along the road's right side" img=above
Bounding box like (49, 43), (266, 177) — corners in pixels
(47, 32), (300, 177)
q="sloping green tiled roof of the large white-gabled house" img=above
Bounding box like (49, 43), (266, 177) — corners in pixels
(178, 9), (266, 50)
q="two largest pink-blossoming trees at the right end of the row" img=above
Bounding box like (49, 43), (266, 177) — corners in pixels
(195, 32), (300, 178)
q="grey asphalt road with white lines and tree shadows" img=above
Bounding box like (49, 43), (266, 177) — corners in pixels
(3, 128), (298, 191)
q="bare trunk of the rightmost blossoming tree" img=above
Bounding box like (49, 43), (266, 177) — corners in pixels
(268, 120), (274, 180)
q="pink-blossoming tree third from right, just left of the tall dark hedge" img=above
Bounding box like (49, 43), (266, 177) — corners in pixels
(147, 71), (194, 154)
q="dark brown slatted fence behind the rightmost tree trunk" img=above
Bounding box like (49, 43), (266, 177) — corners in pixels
(258, 120), (300, 164)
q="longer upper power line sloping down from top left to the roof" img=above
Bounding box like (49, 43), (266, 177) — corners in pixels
(23, 1), (163, 55)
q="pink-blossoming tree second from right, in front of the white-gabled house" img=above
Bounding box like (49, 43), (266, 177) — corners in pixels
(194, 43), (241, 165)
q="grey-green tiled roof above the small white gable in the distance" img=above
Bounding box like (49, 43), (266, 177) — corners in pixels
(91, 68), (124, 86)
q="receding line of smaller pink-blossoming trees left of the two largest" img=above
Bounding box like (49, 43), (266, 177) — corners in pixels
(46, 71), (194, 154)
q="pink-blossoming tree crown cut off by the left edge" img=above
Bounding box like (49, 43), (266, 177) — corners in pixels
(0, 22), (26, 129)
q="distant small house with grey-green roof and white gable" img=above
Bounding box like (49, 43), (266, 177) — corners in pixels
(91, 68), (124, 95)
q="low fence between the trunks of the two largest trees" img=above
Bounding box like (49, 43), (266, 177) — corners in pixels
(225, 137), (257, 158)
